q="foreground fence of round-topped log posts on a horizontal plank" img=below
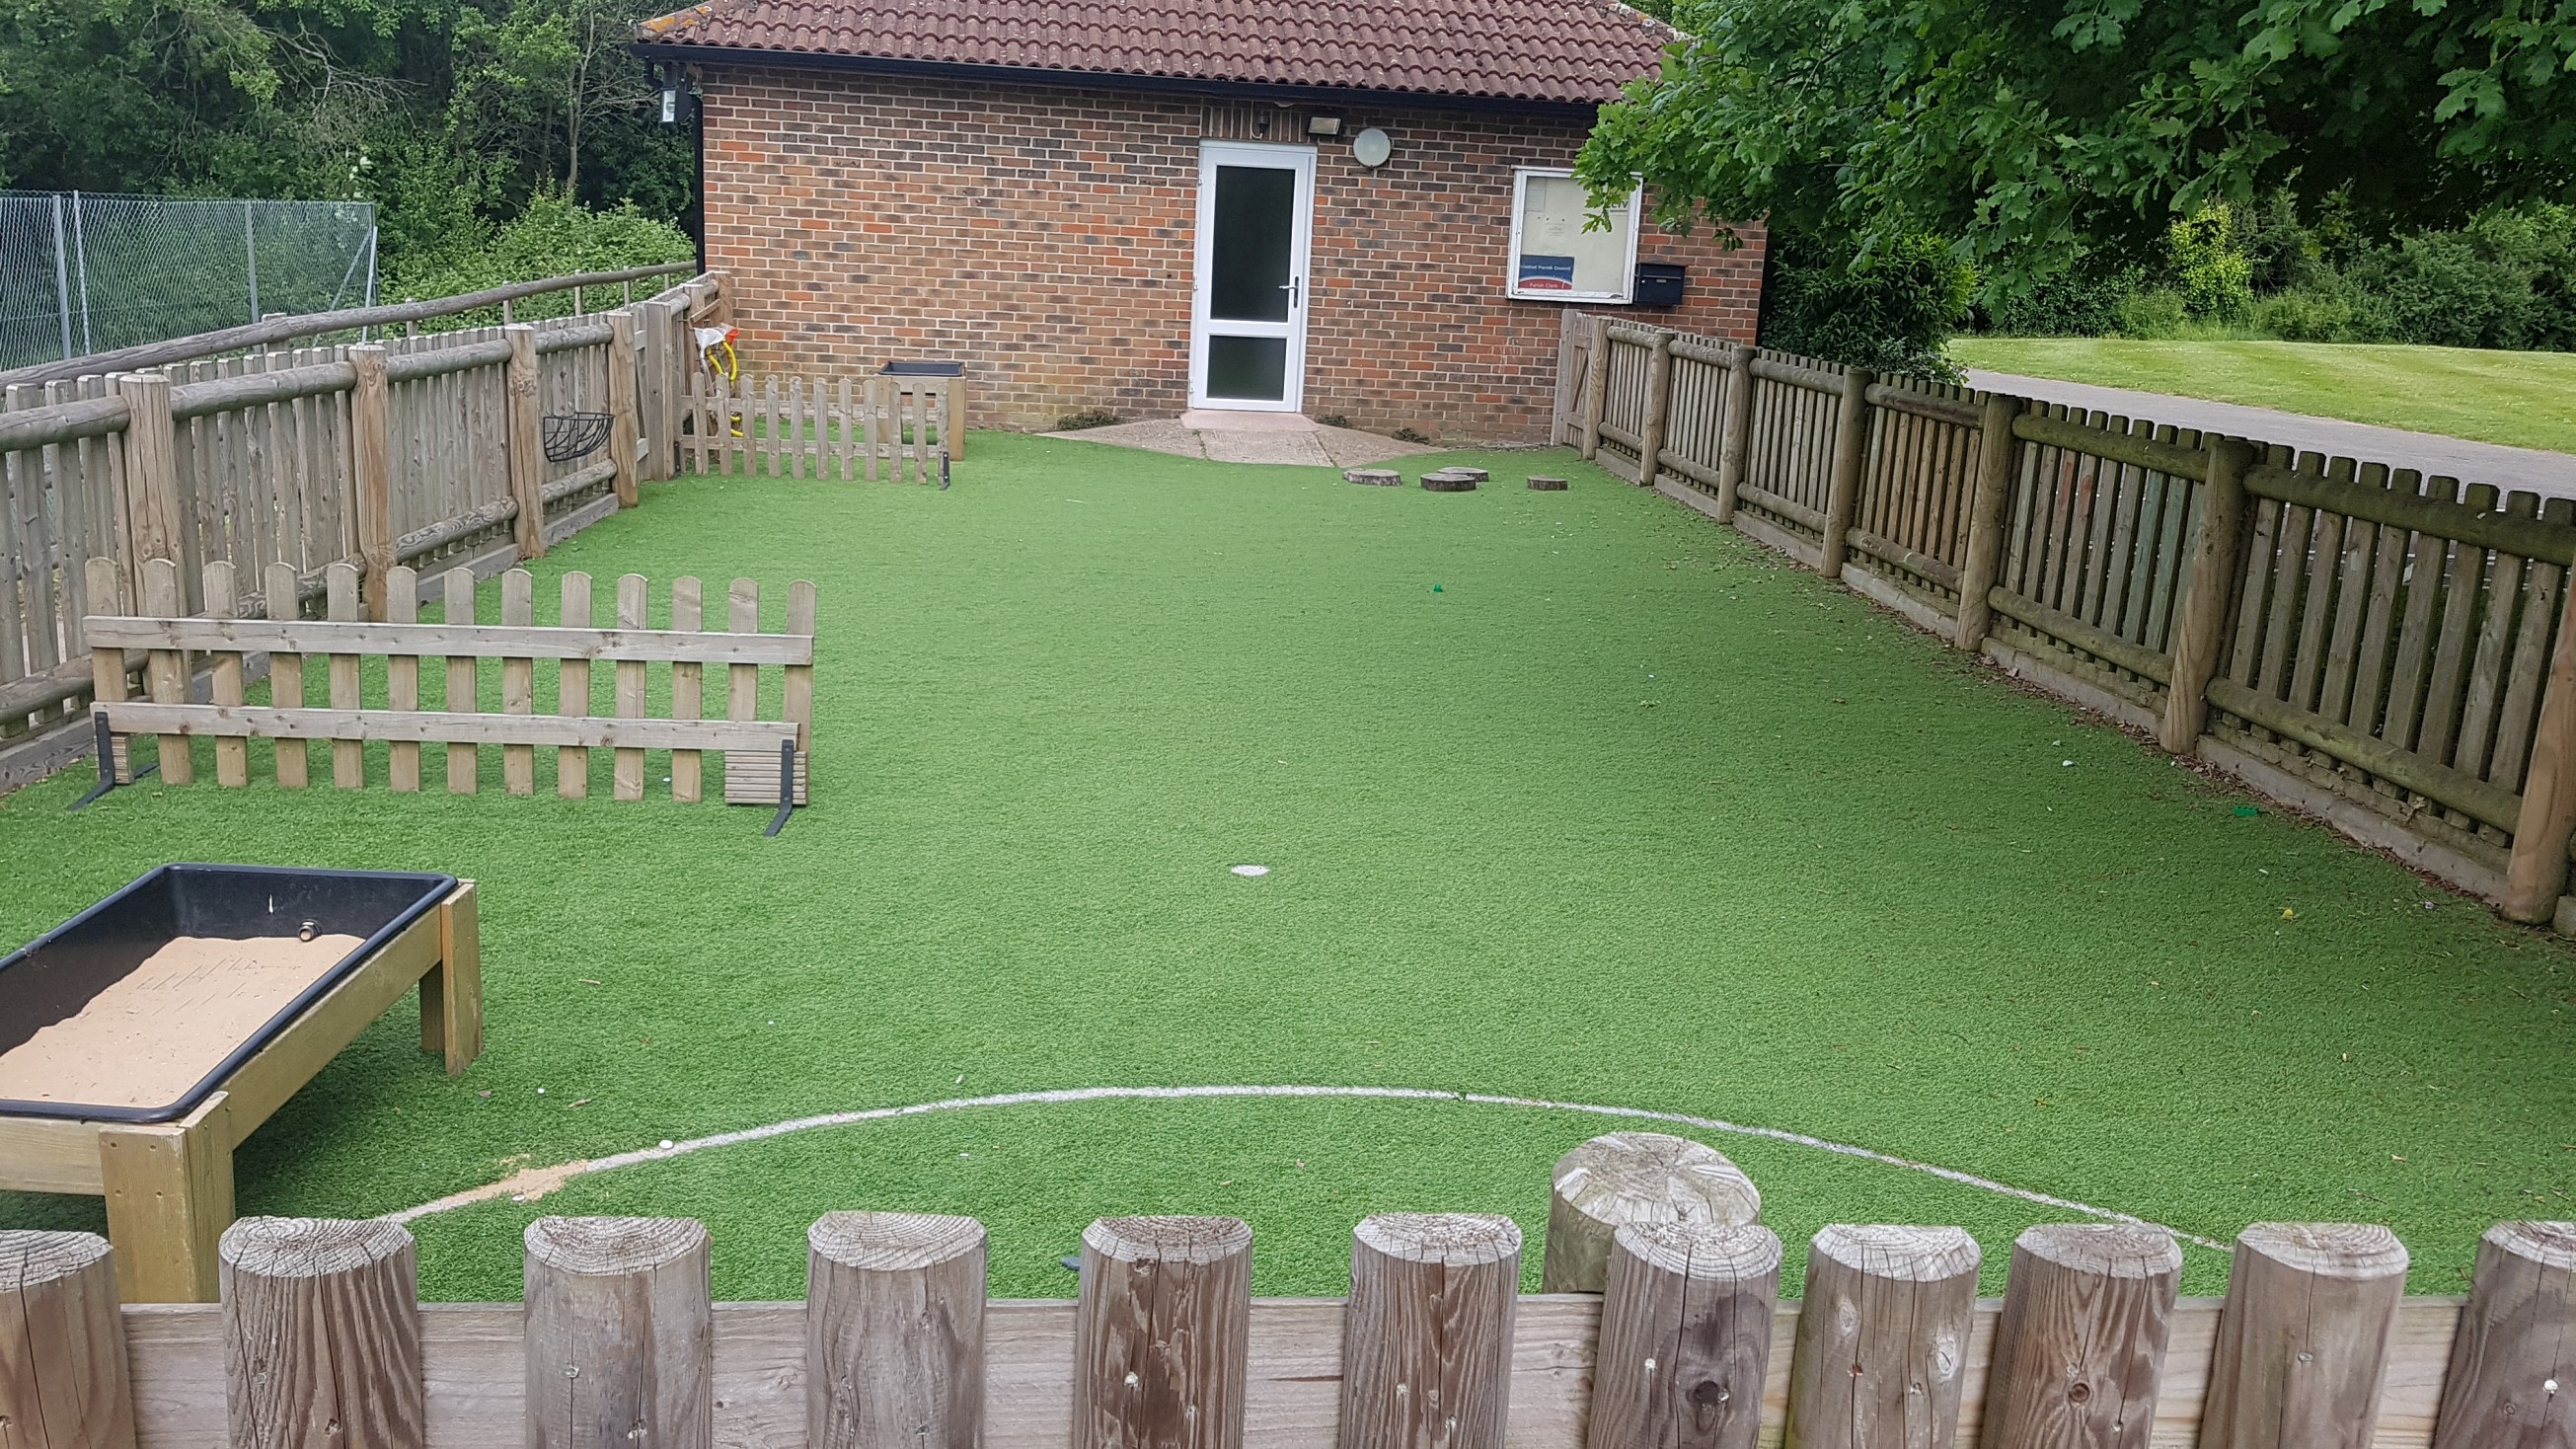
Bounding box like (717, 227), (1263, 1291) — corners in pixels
(0, 1134), (2576, 1449)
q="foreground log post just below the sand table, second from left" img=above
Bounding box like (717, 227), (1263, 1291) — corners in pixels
(216, 1217), (430, 1449)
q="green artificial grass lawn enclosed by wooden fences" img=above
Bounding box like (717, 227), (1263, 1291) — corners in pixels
(0, 433), (2576, 1299)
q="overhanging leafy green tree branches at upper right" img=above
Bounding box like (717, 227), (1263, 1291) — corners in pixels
(1582, 0), (2576, 299)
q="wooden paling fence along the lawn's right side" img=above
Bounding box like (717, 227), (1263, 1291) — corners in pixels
(1555, 312), (2576, 931)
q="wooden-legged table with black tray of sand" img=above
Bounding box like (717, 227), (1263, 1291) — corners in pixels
(0, 864), (482, 1302)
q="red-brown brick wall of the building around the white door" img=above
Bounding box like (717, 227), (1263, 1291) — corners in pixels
(701, 70), (1762, 441)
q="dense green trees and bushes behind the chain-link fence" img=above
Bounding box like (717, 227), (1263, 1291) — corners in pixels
(0, 0), (696, 287)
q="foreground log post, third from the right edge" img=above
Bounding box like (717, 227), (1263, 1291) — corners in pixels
(1978, 1222), (2182, 1449)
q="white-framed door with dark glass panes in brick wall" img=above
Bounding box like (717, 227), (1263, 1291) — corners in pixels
(1190, 142), (1314, 413)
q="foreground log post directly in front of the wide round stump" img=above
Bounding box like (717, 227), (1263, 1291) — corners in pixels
(1584, 1220), (1780, 1449)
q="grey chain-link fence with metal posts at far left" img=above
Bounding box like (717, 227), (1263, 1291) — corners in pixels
(0, 191), (376, 369)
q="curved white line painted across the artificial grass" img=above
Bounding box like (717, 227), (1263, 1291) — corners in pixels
(384, 1083), (2229, 1253)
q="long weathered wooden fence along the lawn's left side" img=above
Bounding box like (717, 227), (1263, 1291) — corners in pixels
(0, 275), (729, 787)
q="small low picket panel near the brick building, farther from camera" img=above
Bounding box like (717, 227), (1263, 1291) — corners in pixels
(680, 371), (966, 482)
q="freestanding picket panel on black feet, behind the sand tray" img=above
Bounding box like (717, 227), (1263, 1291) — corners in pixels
(80, 560), (814, 804)
